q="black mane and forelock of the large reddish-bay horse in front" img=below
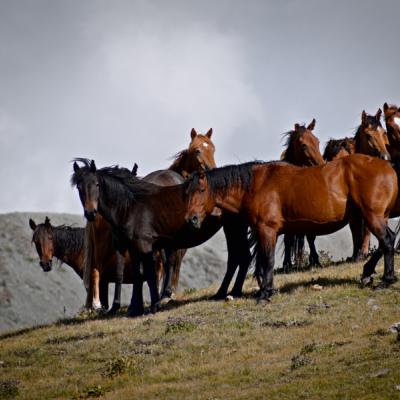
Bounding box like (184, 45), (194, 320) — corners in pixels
(185, 161), (264, 194)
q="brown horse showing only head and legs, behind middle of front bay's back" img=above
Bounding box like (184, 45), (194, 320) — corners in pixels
(281, 119), (325, 272)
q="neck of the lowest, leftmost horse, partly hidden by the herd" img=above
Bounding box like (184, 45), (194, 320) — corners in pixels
(53, 228), (83, 278)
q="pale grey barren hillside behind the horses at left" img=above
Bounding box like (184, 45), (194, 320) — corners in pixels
(0, 213), (225, 331)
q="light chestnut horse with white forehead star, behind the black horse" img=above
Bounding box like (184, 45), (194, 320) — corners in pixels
(84, 129), (216, 312)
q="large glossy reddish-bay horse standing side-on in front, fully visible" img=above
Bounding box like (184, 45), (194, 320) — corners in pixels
(186, 154), (398, 300)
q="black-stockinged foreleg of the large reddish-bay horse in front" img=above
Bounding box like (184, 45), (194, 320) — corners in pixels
(256, 226), (277, 301)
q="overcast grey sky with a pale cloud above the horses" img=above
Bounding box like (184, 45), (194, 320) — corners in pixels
(0, 0), (400, 213)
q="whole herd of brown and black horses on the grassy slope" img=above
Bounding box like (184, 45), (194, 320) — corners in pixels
(29, 103), (400, 316)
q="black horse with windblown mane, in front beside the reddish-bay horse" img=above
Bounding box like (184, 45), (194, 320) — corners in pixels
(71, 159), (251, 316)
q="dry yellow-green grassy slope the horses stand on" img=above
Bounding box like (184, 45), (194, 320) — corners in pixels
(0, 259), (400, 399)
